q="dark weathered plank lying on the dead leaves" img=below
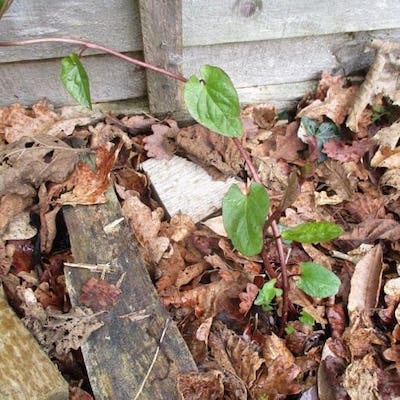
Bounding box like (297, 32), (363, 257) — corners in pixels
(63, 188), (196, 400)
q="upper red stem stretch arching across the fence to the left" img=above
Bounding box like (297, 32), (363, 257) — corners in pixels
(0, 37), (187, 82)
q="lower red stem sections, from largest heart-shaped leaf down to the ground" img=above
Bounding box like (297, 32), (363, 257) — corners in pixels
(233, 138), (289, 336)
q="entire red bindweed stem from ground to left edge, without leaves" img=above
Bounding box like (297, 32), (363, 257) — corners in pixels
(0, 37), (289, 335)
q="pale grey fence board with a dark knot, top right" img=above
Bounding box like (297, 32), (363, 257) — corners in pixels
(182, 0), (400, 46)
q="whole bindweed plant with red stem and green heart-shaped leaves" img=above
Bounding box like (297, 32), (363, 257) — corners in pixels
(0, 28), (341, 333)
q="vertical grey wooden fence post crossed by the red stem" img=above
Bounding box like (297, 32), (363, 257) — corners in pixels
(139, 0), (182, 113)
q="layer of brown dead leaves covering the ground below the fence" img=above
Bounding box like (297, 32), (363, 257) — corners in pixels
(0, 41), (400, 400)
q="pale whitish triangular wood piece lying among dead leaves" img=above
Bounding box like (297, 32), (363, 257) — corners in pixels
(141, 156), (237, 222)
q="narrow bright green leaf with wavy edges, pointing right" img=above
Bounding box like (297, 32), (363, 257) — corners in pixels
(281, 221), (343, 243)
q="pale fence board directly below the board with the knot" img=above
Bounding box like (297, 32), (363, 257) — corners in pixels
(183, 30), (400, 88)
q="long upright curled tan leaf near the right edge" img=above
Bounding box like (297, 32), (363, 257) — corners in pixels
(347, 244), (383, 326)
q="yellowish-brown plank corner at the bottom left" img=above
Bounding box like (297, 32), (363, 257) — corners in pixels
(0, 285), (68, 400)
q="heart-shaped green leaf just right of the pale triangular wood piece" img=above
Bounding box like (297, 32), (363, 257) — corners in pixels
(222, 183), (269, 256)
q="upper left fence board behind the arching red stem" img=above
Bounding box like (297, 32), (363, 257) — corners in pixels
(0, 0), (142, 62)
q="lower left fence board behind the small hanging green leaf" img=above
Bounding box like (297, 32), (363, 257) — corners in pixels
(0, 53), (146, 106)
